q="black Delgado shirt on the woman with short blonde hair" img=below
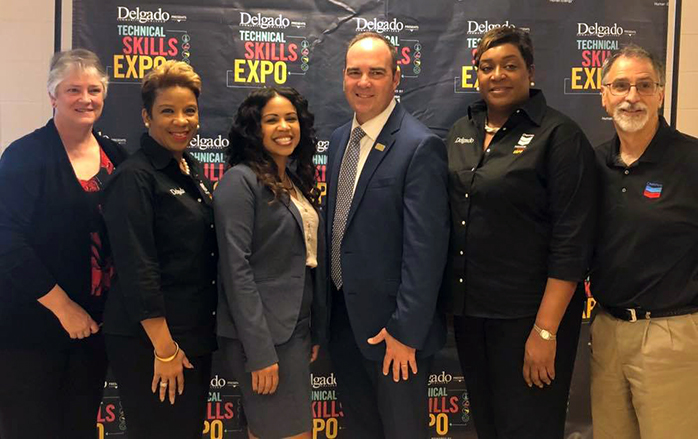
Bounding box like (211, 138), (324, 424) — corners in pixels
(104, 134), (218, 355)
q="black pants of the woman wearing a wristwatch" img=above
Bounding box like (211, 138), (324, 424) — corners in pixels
(454, 297), (583, 439)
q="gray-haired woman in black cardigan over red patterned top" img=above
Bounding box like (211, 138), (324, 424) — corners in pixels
(0, 49), (126, 439)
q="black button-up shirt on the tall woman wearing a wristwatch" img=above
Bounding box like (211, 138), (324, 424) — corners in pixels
(444, 90), (596, 318)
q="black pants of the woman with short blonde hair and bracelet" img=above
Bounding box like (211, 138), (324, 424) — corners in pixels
(106, 335), (211, 439)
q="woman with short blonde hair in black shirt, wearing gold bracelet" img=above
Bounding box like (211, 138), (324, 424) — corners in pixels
(104, 61), (217, 439)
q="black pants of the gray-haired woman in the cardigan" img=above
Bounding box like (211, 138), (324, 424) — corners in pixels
(0, 333), (107, 439)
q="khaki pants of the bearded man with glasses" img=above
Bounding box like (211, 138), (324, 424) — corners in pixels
(591, 310), (698, 439)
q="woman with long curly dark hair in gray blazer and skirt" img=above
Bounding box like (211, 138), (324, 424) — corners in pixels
(214, 87), (327, 439)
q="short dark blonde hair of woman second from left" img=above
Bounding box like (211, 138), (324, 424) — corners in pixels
(141, 60), (201, 116)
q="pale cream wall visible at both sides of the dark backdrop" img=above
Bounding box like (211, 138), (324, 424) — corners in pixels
(0, 0), (698, 152)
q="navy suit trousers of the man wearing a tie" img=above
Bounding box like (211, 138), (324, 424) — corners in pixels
(329, 289), (433, 439)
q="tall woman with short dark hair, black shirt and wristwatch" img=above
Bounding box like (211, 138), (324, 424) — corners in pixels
(445, 27), (596, 439)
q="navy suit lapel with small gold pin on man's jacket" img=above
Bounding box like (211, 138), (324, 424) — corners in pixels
(346, 104), (405, 229)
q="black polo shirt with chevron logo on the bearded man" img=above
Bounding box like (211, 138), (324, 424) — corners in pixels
(591, 118), (698, 311)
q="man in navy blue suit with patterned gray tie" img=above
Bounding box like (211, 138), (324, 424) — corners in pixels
(326, 33), (449, 439)
